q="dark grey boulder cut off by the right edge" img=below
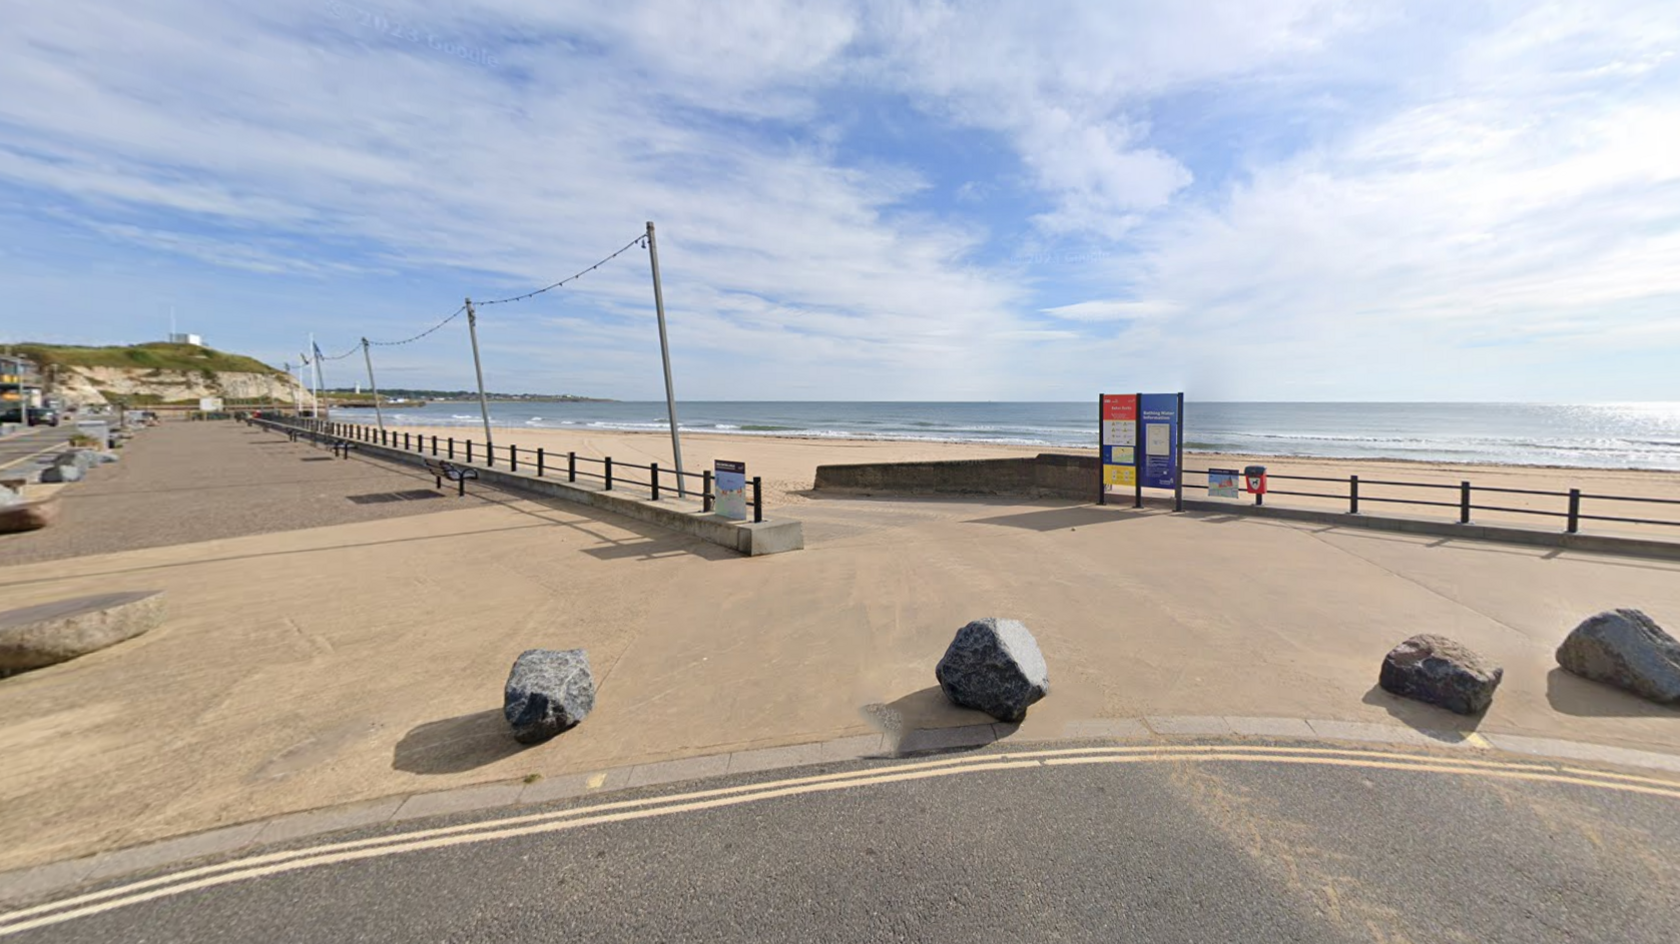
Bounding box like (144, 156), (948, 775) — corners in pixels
(1557, 610), (1680, 705)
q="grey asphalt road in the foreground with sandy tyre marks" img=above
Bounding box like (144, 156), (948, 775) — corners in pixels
(0, 749), (1680, 944)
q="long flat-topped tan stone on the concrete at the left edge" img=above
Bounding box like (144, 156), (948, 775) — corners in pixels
(0, 590), (163, 672)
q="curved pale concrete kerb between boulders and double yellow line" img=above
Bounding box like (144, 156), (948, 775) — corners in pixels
(0, 716), (1680, 904)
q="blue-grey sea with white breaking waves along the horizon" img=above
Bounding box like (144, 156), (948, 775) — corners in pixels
(371, 396), (1680, 470)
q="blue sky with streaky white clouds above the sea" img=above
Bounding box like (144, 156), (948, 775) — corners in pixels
(0, 0), (1680, 401)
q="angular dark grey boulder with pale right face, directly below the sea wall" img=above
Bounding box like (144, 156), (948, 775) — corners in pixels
(934, 616), (1050, 722)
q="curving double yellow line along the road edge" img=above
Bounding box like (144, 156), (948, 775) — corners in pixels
(0, 744), (1680, 937)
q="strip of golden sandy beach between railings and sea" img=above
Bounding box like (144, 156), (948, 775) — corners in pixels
(384, 417), (1680, 539)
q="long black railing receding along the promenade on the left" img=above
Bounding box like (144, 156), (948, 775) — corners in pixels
(252, 413), (764, 522)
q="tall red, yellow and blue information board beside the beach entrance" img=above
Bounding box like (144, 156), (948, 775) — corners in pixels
(1097, 393), (1184, 511)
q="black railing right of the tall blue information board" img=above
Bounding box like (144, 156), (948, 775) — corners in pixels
(1184, 469), (1680, 534)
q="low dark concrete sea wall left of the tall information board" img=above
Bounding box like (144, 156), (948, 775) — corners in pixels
(815, 452), (1100, 501)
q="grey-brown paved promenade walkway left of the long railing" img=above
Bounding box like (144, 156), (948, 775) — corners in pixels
(0, 422), (482, 566)
